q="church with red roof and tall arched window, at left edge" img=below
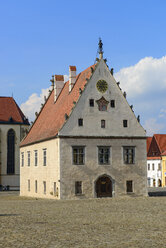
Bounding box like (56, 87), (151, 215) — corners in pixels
(0, 97), (29, 190)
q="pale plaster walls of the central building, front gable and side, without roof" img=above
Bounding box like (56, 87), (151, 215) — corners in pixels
(20, 55), (147, 199)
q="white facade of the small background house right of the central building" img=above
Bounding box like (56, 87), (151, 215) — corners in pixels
(147, 159), (162, 187)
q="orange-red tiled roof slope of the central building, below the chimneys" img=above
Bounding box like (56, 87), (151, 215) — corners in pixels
(20, 65), (95, 147)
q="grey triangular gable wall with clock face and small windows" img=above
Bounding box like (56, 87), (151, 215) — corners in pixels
(59, 60), (145, 136)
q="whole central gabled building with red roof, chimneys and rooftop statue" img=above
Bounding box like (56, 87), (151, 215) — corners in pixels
(20, 40), (147, 199)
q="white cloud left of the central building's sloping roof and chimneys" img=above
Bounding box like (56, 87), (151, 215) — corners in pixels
(20, 88), (50, 121)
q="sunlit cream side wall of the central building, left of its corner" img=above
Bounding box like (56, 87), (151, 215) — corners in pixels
(20, 139), (60, 199)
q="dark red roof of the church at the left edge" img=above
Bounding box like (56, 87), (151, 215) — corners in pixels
(0, 96), (29, 125)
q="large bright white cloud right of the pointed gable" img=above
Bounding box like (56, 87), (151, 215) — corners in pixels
(115, 56), (166, 98)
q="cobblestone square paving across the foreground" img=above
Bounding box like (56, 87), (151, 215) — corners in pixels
(0, 192), (166, 248)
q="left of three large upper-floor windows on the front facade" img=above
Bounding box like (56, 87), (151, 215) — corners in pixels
(72, 146), (85, 165)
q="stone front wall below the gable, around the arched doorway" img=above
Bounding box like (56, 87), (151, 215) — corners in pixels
(60, 138), (147, 199)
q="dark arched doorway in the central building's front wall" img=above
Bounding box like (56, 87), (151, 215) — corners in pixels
(95, 176), (112, 197)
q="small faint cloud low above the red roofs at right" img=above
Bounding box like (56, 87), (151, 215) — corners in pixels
(144, 118), (164, 136)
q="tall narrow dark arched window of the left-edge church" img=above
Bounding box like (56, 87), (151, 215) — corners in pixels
(7, 129), (15, 174)
